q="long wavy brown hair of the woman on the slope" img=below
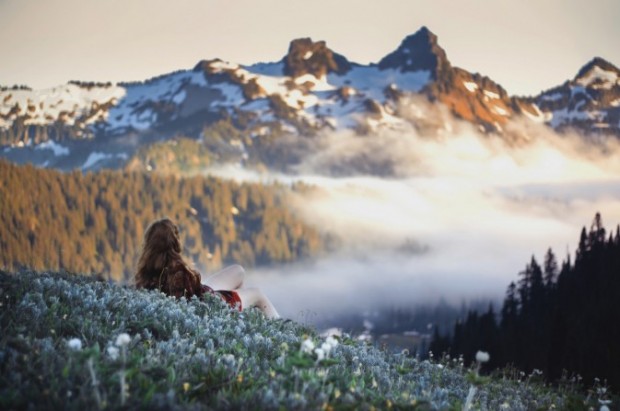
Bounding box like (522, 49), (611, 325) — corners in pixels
(134, 218), (185, 289)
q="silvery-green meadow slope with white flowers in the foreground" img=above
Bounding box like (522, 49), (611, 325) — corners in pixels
(0, 272), (612, 410)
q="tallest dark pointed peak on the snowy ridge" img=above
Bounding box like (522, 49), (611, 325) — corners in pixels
(379, 26), (450, 79)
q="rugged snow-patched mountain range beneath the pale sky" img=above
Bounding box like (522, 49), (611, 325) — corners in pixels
(0, 27), (620, 171)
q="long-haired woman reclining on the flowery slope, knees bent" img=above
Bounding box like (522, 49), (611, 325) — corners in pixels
(135, 218), (280, 318)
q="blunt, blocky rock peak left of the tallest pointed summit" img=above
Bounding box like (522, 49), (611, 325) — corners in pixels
(282, 37), (351, 78)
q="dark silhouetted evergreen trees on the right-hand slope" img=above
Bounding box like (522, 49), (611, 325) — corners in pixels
(431, 213), (620, 390)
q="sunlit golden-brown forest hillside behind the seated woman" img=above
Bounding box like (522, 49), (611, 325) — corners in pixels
(0, 160), (325, 281)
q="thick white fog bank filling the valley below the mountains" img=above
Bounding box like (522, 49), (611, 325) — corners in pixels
(203, 100), (620, 326)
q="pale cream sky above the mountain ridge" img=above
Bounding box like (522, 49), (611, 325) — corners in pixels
(0, 0), (620, 95)
